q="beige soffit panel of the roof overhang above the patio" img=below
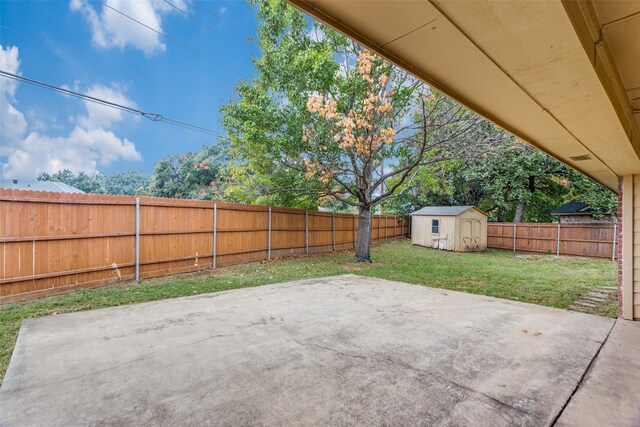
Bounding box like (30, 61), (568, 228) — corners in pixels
(289, 0), (640, 190)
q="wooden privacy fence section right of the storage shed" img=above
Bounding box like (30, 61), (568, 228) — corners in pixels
(487, 222), (617, 259)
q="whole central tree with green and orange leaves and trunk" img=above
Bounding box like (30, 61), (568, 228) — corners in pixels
(222, 0), (500, 259)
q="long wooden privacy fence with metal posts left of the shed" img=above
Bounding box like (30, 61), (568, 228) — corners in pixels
(0, 189), (408, 302)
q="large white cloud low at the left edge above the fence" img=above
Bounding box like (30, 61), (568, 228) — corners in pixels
(0, 45), (142, 180)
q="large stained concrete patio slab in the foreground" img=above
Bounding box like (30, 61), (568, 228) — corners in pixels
(0, 275), (614, 426)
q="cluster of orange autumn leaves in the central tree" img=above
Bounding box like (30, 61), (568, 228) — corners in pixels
(302, 50), (396, 185)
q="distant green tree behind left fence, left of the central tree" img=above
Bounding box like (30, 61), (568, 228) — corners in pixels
(148, 143), (229, 200)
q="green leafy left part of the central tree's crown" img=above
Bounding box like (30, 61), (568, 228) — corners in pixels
(222, 1), (336, 209)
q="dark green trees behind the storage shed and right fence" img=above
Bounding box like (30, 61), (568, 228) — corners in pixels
(378, 139), (617, 222)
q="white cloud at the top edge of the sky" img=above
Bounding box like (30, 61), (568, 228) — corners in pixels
(69, 0), (187, 56)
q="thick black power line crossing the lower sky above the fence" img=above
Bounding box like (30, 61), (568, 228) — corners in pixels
(0, 70), (227, 139)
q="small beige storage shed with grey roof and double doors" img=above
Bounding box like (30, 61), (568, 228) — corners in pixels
(411, 206), (487, 252)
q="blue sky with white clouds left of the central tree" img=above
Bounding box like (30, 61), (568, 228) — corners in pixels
(0, 0), (259, 180)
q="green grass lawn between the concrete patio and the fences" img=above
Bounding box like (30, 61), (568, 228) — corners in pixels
(0, 240), (617, 381)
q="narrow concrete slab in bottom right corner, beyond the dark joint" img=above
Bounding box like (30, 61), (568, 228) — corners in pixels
(557, 319), (640, 427)
